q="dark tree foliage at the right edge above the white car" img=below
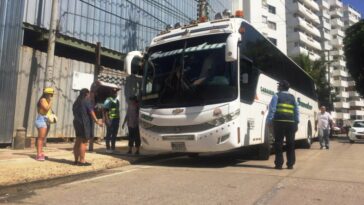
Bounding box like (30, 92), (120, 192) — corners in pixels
(344, 20), (364, 96)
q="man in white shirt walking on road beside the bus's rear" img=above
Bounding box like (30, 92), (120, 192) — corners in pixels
(315, 106), (333, 149)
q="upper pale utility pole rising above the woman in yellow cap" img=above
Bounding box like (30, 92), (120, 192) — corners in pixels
(44, 0), (58, 88)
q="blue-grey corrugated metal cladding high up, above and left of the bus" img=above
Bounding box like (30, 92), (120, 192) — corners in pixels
(24, 0), (232, 53)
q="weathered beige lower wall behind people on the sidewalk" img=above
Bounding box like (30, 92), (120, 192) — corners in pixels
(14, 46), (126, 138)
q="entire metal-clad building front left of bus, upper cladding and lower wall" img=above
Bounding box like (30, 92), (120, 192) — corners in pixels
(0, 0), (232, 143)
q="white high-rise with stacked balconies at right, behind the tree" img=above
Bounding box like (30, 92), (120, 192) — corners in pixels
(286, 0), (364, 126)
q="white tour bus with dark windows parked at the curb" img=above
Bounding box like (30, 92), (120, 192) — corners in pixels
(125, 11), (317, 159)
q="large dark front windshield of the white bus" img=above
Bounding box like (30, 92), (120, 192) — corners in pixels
(141, 35), (238, 108)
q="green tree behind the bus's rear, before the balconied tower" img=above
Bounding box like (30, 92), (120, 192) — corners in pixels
(293, 54), (334, 110)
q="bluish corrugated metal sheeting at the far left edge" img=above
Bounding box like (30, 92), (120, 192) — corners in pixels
(0, 0), (24, 143)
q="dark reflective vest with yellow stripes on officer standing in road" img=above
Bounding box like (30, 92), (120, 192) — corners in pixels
(273, 92), (296, 123)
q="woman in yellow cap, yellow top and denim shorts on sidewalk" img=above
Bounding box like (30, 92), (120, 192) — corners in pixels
(35, 87), (54, 161)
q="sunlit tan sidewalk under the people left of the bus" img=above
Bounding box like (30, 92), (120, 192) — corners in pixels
(0, 140), (170, 189)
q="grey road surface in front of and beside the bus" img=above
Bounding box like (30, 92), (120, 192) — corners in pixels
(2, 140), (364, 205)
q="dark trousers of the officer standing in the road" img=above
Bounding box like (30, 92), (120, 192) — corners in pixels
(273, 121), (296, 167)
